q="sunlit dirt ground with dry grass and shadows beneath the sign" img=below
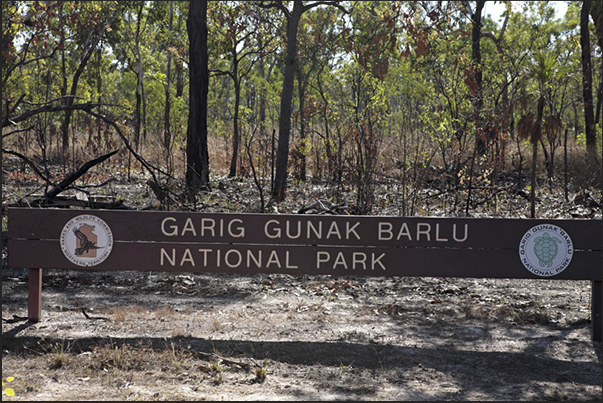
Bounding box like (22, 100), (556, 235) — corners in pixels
(2, 177), (603, 401)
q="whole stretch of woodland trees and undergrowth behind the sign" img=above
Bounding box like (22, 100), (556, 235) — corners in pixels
(2, 1), (603, 217)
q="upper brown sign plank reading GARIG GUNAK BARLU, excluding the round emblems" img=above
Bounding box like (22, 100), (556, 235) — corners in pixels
(9, 208), (602, 251)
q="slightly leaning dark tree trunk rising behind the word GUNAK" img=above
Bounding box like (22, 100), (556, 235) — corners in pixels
(272, 0), (303, 203)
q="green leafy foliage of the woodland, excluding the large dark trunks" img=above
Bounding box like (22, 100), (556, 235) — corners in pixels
(2, 1), (601, 205)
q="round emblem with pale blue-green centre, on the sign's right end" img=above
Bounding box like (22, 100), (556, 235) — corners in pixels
(519, 224), (574, 277)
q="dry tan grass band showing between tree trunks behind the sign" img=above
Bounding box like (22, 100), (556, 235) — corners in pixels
(4, 123), (602, 193)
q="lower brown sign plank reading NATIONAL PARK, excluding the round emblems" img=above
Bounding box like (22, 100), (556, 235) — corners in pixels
(9, 240), (602, 281)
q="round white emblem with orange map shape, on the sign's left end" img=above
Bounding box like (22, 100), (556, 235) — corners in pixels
(61, 215), (113, 267)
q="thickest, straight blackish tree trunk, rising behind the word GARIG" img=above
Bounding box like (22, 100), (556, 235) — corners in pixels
(186, 0), (210, 193)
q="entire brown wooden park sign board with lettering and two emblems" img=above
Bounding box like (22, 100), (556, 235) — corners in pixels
(8, 208), (603, 340)
